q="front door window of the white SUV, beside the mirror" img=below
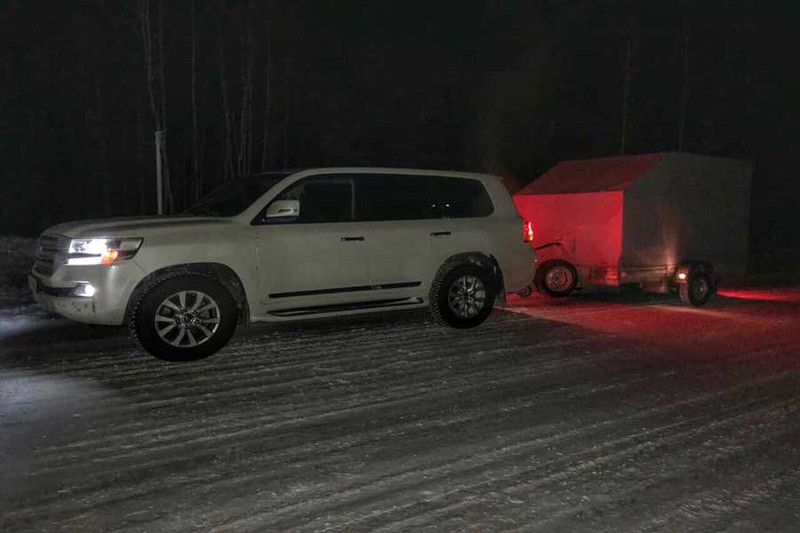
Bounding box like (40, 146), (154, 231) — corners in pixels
(259, 176), (354, 224)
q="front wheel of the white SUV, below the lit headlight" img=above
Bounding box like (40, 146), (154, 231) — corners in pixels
(128, 274), (237, 361)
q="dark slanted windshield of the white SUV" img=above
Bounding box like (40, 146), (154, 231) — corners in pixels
(186, 172), (291, 217)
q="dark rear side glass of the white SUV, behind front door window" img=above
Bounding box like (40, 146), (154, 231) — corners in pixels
(354, 174), (494, 221)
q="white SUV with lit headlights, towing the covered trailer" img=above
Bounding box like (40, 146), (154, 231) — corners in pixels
(29, 168), (535, 360)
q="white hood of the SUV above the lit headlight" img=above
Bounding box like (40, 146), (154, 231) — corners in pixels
(43, 215), (230, 238)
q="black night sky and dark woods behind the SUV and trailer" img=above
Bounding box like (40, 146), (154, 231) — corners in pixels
(0, 0), (800, 252)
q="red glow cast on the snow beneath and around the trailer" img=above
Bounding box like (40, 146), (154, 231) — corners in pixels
(509, 287), (800, 357)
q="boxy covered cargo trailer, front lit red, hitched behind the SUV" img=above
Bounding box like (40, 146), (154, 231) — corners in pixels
(514, 152), (752, 305)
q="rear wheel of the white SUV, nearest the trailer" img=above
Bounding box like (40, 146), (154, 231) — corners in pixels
(430, 264), (497, 329)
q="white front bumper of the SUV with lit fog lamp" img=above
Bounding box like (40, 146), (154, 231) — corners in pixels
(28, 260), (144, 326)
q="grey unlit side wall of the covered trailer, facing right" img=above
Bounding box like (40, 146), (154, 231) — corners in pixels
(620, 154), (751, 275)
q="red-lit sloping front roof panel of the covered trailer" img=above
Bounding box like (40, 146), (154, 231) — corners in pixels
(517, 153), (667, 194)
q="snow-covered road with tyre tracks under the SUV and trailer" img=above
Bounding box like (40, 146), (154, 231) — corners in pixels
(0, 288), (800, 532)
